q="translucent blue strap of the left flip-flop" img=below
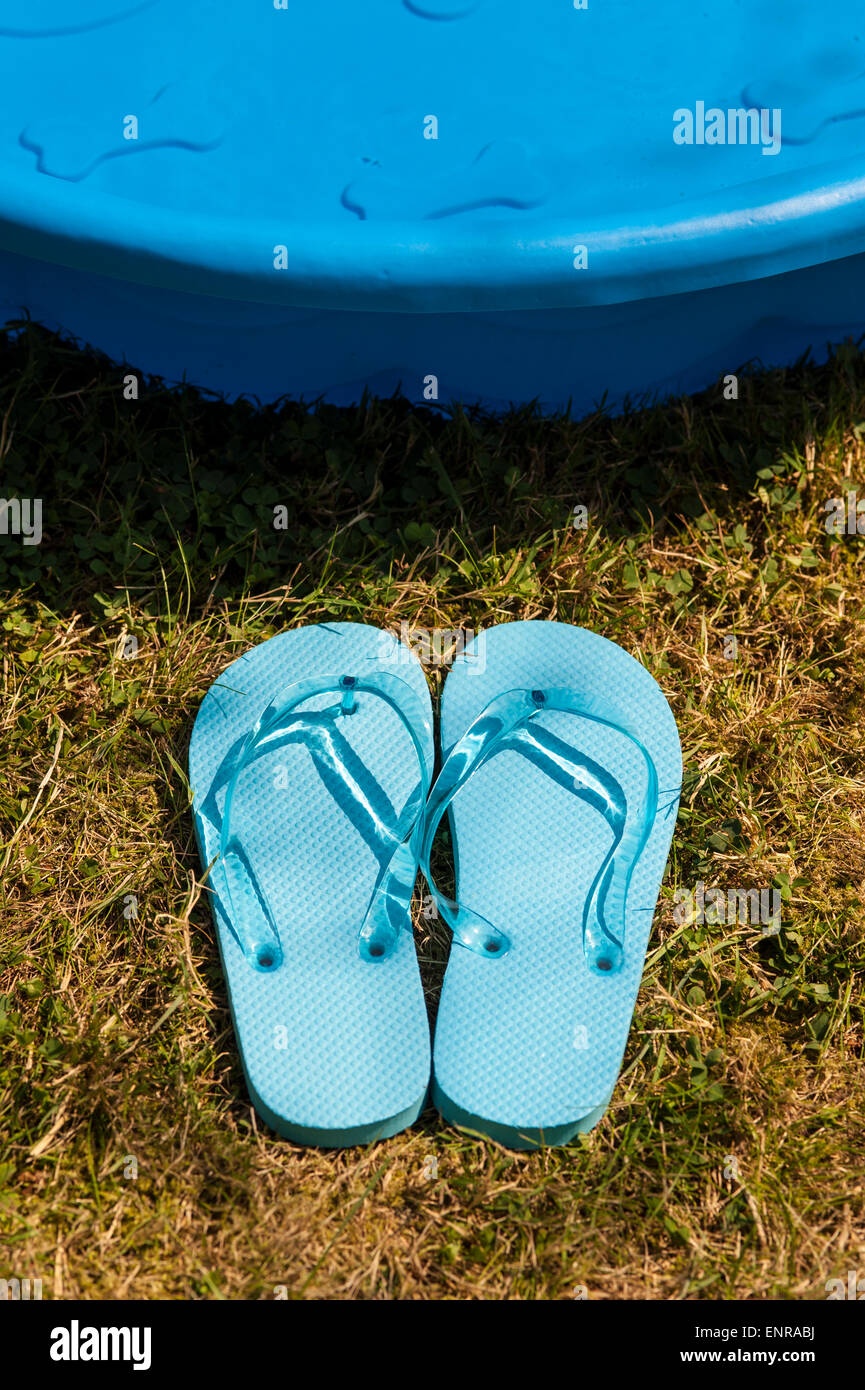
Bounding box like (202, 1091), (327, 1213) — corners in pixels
(214, 671), (433, 970)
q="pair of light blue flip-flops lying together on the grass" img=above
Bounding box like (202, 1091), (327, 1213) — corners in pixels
(189, 621), (681, 1148)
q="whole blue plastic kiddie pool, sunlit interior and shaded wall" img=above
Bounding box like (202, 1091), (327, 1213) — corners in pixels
(0, 0), (865, 411)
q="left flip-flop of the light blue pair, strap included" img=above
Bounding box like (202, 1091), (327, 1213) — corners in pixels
(189, 623), (434, 1148)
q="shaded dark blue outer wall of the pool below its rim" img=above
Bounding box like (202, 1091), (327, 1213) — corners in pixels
(6, 252), (865, 416)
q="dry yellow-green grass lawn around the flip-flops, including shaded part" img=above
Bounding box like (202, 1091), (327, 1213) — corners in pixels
(0, 319), (865, 1300)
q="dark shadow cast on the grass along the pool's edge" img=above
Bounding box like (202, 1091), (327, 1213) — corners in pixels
(0, 324), (865, 616)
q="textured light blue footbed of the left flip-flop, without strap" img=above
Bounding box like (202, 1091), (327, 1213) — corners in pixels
(189, 623), (434, 1145)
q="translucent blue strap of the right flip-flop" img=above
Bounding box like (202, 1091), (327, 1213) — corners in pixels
(420, 689), (658, 974)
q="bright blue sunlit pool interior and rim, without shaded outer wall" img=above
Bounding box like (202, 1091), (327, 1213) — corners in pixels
(0, 0), (865, 313)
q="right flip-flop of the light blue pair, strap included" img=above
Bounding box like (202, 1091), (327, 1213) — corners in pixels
(421, 621), (681, 1148)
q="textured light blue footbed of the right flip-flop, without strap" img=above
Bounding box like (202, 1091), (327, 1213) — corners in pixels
(434, 623), (681, 1147)
